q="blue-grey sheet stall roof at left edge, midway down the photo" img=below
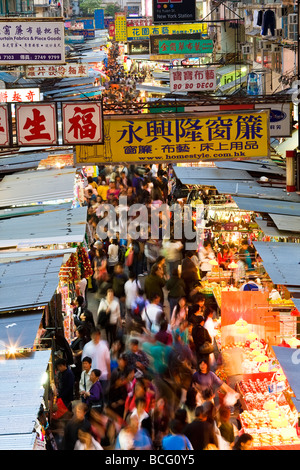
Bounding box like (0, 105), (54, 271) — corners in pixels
(0, 254), (63, 310)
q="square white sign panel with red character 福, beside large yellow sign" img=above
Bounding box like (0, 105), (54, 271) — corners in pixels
(62, 102), (103, 145)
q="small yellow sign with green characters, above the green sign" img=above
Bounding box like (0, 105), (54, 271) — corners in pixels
(127, 23), (207, 41)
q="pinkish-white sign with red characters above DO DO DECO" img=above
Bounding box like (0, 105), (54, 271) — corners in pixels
(170, 67), (217, 91)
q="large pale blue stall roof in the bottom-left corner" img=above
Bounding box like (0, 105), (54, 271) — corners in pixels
(0, 350), (51, 450)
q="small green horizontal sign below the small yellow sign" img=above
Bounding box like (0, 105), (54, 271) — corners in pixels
(159, 39), (213, 55)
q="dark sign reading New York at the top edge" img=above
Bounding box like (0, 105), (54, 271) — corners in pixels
(153, 0), (196, 23)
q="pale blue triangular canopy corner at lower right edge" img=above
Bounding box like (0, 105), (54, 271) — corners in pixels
(272, 346), (300, 412)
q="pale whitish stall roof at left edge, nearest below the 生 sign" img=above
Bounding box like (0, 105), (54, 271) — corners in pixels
(0, 168), (76, 207)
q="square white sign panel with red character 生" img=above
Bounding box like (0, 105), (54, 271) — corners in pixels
(16, 103), (58, 146)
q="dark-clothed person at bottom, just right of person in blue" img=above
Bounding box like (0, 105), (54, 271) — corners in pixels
(183, 406), (218, 450)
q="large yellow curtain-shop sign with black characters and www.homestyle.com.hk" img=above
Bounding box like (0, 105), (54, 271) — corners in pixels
(76, 111), (269, 165)
